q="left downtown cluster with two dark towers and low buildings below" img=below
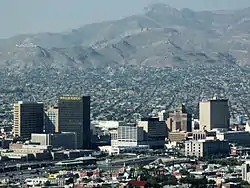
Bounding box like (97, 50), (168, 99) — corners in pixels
(1, 96), (91, 160)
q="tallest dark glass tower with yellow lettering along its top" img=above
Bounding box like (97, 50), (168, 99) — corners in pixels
(58, 96), (91, 149)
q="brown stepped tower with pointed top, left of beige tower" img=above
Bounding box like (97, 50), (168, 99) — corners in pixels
(167, 104), (192, 132)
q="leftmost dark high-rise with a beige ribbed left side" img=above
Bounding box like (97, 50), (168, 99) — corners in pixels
(13, 101), (44, 140)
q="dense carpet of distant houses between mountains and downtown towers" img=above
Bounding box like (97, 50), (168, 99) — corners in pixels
(0, 63), (250, 121)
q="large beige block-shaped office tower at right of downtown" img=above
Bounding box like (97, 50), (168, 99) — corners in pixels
(200, 98), (230, 131)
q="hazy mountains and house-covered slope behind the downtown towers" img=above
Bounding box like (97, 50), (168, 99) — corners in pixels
(0, 4), (250, 121)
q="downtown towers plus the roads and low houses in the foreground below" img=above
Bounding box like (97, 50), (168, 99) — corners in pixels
(0, 95), (250, 188)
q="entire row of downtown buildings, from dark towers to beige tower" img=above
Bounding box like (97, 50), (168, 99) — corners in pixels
(2, 96), (250, 160)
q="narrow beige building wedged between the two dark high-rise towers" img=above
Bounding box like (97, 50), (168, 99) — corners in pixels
(44, 107), (59, 133)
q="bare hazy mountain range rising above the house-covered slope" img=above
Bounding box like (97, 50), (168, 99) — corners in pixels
(0, 4), (250, 70)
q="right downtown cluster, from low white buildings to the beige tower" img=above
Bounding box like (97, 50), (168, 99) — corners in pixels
(96, 98), (235, 157)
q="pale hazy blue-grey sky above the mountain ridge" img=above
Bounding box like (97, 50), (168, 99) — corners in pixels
(0, 0), (250, 38)
